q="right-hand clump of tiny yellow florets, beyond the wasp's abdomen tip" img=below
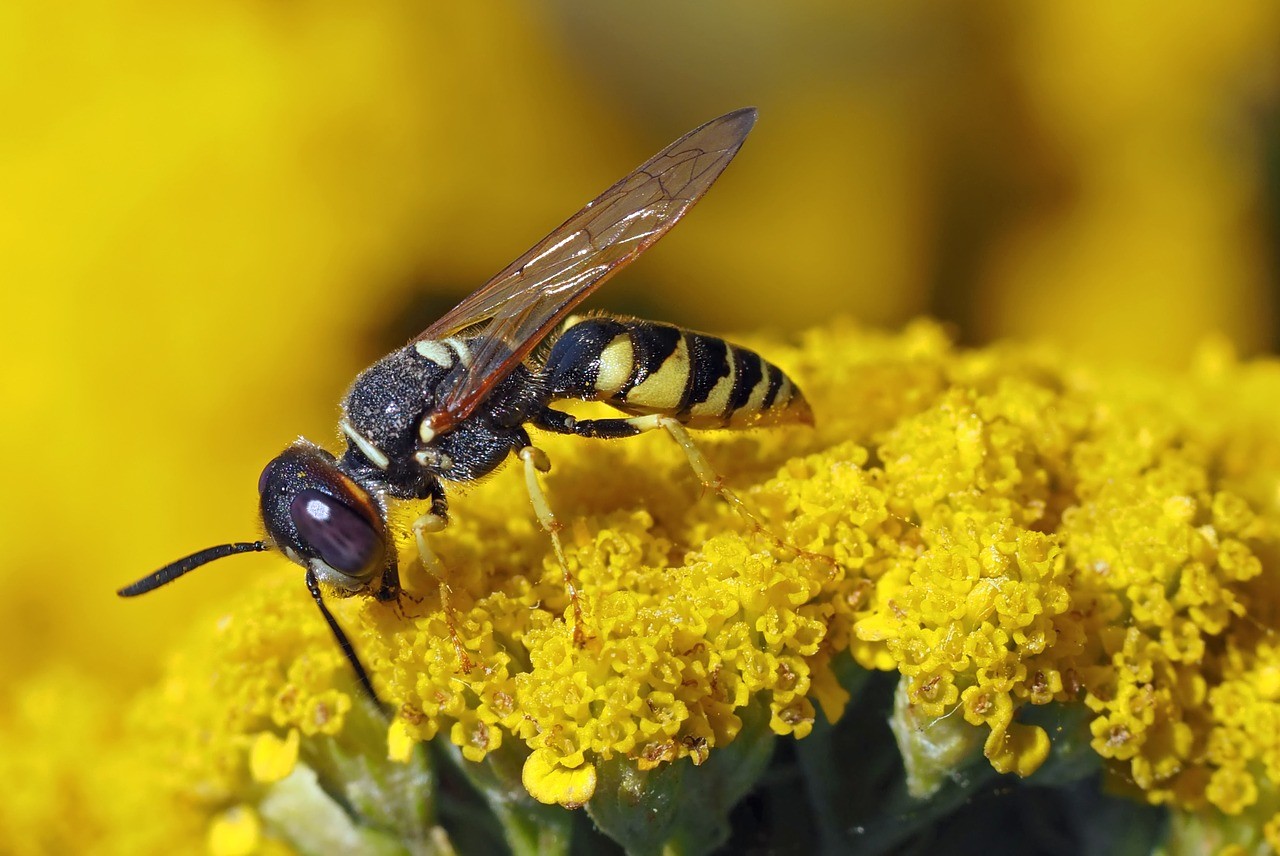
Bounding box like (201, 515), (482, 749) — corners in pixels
(855, 330), (1280, 814)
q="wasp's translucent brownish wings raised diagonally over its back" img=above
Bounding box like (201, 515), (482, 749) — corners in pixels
(415, 107), (755, 431)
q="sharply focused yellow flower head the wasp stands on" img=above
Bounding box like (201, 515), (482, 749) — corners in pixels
(62, 318), (1280, 852)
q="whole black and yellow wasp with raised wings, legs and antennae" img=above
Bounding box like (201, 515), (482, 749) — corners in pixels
(118, 109), (813, 700)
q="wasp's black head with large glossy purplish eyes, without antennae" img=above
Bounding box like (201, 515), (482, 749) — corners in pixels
(257, 440), (388, 591)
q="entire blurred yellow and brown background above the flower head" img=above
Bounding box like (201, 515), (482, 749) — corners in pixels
(0, 0), (1280, 747)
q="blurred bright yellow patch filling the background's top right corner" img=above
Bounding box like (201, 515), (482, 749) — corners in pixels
(974, 0), (1280, 365)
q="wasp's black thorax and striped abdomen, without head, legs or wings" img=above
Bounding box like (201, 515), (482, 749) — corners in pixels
(340, 316), (813, 504)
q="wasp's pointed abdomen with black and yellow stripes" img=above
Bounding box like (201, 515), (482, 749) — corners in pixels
(545, 317), (813, 429)
